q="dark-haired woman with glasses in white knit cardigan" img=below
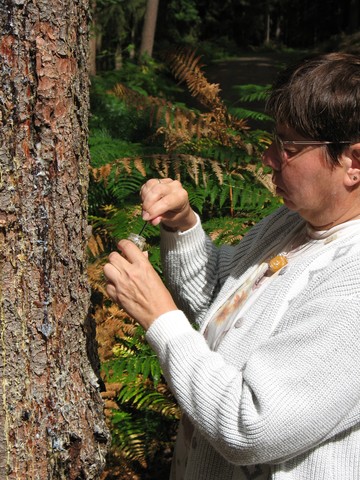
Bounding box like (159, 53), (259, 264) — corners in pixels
(104, 53), (360, 480)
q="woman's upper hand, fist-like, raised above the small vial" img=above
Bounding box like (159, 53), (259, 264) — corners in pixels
(140, 178), (196, 232)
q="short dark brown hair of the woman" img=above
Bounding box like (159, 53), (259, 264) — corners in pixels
(266, 52), (360, 163)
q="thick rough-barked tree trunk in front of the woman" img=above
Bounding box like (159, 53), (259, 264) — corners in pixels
(0, 0), (109, 480)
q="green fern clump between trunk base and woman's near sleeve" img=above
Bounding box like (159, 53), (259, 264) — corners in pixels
(103, 326), (180, 465)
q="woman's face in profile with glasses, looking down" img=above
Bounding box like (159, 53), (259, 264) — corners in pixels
(263, 125), (345, 226)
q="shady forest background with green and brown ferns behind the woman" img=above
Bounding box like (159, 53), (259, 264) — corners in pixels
(89, 0), (360, 480)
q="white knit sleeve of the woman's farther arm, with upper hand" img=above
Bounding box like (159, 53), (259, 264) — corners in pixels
(161, 208), (298, 326)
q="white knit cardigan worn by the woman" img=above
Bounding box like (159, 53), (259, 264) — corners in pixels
(147, 207), (360, 480)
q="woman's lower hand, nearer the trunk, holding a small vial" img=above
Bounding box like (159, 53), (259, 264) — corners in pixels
(104, 240), (177, 330)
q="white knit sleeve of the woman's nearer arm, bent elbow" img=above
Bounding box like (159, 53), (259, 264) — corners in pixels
(147, 258), (360, 465)
